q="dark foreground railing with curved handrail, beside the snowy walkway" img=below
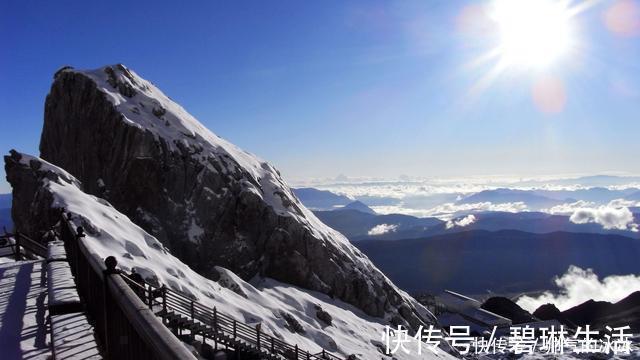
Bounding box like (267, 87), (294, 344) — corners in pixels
(60, 214), (195, 360)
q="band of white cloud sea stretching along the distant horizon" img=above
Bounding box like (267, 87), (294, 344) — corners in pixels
(299, 176), (640, 224)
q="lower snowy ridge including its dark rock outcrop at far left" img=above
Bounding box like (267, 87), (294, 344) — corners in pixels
(5, 152), (453, 360)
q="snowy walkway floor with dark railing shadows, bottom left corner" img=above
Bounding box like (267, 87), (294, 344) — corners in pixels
(0, 261), (51, 360)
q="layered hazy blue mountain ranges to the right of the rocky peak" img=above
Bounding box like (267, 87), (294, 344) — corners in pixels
(292, 186), (640, 294)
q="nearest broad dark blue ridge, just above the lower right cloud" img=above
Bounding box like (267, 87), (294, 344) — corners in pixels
(355, 230), (640, 294)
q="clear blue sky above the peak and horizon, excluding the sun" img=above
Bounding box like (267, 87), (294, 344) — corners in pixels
(0, 0), (640, 192)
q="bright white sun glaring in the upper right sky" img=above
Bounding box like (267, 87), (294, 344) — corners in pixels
(490, 0), (573, 67)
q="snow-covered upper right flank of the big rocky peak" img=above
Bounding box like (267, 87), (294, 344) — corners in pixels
(69, 64), (306, 218)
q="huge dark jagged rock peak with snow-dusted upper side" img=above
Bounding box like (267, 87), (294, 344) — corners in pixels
(40, 65), (434, 328)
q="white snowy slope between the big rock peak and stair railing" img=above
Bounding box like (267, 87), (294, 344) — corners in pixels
(7, 154), (452, 359)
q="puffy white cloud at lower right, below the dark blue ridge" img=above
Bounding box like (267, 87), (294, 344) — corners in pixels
(517, 265), (640, 312)
